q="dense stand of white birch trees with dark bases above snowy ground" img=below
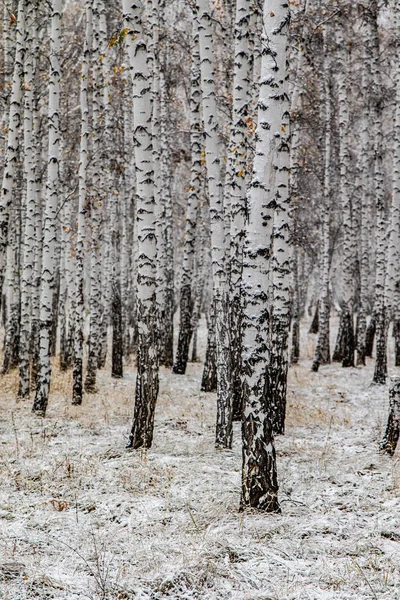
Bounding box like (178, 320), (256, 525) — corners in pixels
(0, 0), (400, 511)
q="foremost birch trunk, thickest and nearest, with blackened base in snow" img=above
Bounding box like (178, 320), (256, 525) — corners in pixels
(241, 0), (289, 512)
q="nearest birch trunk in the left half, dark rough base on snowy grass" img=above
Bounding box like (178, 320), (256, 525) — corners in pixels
(123, 0), (159, 448)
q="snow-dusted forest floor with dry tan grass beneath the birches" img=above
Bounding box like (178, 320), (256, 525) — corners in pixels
(0, 316), (400, 600)
